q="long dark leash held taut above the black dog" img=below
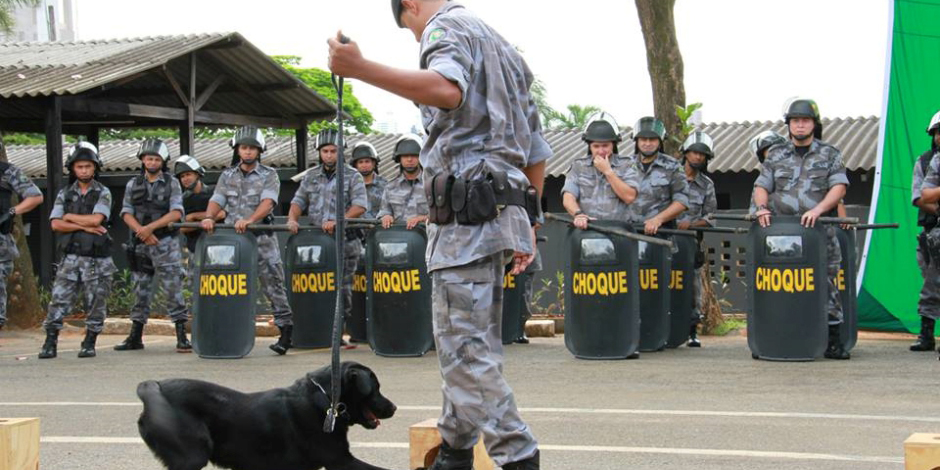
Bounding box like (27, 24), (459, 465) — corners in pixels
(323, 35), (349, 433)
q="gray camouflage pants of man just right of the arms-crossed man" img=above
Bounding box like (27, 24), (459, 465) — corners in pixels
(131, 237), (189, 324)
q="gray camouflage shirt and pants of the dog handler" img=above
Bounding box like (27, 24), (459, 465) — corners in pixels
(420, 2), (551, 466)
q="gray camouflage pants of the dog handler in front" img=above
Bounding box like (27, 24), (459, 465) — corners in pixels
(431, 253), (538, 466)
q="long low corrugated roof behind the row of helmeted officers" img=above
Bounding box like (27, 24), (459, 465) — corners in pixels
(7, 117), (878, 178)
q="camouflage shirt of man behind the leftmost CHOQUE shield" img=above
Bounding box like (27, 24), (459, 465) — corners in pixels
(209, 163), (281, 224)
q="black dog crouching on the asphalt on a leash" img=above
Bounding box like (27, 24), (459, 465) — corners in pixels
(137, 362), (395, 470)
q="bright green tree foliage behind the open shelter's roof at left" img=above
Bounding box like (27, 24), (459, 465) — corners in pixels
(271, 55), (375, 134)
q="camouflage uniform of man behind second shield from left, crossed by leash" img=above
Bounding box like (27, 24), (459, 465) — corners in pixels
(290, 165), (370, 318)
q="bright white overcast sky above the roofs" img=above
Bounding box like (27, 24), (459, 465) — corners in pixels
(76, 0), (892, 132)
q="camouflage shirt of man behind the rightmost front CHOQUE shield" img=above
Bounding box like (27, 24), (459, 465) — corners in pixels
(754, 139), (849, 215)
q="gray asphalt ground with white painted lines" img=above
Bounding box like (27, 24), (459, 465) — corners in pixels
(0, 330), (940, 470)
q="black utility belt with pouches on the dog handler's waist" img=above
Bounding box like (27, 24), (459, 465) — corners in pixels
(424, 171), (541, 225)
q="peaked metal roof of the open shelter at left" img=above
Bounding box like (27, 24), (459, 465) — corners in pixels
(0, 33), (335, 126)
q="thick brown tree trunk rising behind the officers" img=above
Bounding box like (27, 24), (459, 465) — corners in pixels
(635, 0), (685, 154)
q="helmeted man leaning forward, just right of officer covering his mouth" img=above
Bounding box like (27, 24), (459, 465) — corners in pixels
(629, 117), (689, 235)
